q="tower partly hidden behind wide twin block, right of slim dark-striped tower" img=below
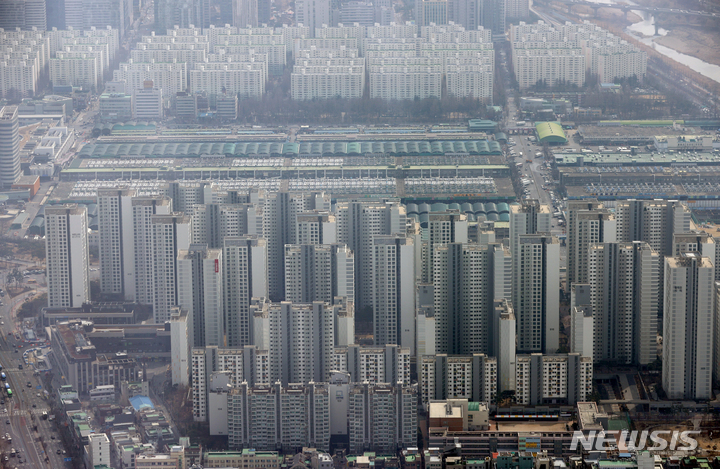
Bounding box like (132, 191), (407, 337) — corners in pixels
(565, 203), (617, 291)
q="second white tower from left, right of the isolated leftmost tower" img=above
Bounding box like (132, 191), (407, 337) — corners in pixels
(97, 189), (136, 301)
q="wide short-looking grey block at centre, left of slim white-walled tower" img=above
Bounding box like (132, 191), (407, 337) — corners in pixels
(285, 244), (355, 303)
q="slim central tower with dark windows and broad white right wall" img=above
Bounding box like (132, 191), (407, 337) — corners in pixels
(371, 235), (415, 354)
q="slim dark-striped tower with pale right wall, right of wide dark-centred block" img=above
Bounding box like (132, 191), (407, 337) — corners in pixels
(513, 234), (560, 353)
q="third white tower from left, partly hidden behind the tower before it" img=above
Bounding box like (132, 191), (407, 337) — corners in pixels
(131, 196), (172, 305)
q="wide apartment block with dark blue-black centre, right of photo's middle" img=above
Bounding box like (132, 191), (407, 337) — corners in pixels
(434, 243), (510, 354)
